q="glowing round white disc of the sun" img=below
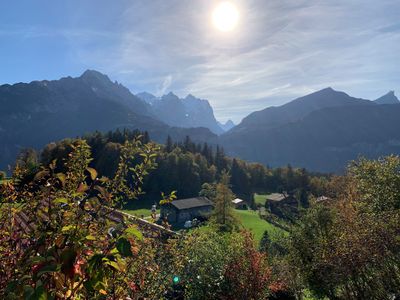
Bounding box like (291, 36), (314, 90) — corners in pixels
(212, 1), (239, 32)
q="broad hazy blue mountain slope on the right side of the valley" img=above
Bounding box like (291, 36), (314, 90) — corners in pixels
(220, 89), (400, 172)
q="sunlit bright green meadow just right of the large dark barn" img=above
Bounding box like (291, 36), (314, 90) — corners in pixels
(235, 209), (282, 242)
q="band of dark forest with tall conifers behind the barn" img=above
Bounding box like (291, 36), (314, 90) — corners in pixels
(18, 129), (330, 208)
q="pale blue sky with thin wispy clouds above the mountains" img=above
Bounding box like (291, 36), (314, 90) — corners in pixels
(0, 0), (400, 122)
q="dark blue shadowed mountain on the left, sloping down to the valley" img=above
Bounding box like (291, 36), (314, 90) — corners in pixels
(0, 71), (216, 169)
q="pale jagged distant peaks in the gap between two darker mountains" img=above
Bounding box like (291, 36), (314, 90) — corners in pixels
(136, 92), (225, 134)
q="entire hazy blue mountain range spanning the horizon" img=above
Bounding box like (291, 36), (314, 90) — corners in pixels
(0, 70), (400, 172)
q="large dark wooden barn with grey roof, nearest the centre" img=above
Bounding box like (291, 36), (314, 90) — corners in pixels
(160, 197), (214, 223)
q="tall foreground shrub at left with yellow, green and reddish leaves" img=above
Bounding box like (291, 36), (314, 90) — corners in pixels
(0, 140), (157, 299)
